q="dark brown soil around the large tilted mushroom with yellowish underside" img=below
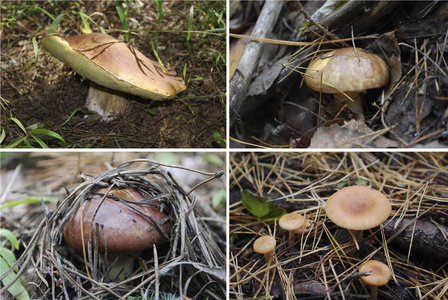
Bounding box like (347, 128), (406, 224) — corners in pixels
(1, 1), (226, 148)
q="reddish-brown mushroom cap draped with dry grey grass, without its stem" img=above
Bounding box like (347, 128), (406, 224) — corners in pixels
(64, 188), (170, 252)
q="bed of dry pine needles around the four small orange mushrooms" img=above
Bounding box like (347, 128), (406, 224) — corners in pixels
(229, 152), (448, 299)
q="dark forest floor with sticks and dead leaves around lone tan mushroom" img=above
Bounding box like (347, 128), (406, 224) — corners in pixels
(229, 1), (448, 148)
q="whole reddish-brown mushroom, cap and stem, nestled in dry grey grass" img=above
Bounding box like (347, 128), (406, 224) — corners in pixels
(64, 188), (170, 281)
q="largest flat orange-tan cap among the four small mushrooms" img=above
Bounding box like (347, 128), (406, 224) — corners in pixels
(325, 185), (392, 230)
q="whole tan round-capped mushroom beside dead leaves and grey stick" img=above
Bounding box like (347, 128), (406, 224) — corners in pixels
(305, 47), (390, 114)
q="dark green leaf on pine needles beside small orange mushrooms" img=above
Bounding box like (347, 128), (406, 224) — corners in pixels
(241, 190), (286, 220)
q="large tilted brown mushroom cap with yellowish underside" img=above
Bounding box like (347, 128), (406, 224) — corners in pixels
(41, 33), (186, 100)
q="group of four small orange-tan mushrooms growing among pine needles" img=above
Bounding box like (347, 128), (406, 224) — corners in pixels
(253, 185), (392, 300)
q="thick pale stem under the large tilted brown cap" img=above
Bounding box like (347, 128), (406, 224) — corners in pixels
(86, 81), (129, 122)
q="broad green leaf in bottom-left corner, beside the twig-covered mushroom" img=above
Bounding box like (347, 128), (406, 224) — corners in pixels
(0, 247), (30, 300)
